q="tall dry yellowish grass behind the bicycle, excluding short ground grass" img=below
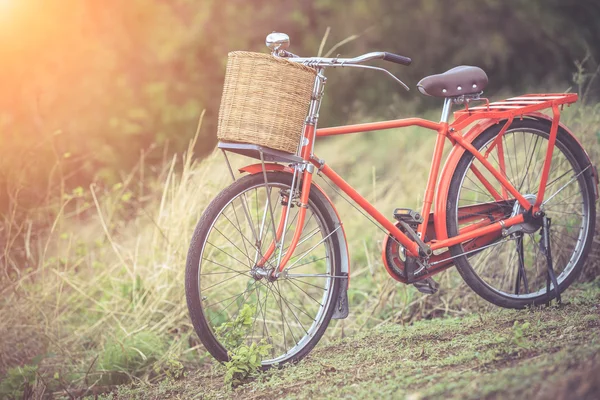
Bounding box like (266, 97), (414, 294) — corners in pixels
(0, 101), (600, 396)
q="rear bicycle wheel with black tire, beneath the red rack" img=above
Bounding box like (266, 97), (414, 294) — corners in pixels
(447, 119), (596, 308)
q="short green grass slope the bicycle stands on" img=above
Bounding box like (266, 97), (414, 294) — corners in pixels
(98, 281), (600, 399)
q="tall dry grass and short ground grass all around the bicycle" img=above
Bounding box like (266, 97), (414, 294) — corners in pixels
(0, 94), (600, 398)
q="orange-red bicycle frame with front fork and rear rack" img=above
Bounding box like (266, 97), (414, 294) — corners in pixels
(258, 93), (577, 271)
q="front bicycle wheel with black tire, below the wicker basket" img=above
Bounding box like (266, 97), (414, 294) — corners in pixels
(185, 172), (341, 367)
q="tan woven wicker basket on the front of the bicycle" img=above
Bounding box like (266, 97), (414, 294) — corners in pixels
(217, 51), (316, 153)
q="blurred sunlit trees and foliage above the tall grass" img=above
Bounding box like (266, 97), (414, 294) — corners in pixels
(0, 0), (600, 214)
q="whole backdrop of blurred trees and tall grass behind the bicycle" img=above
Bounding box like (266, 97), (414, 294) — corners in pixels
(0, 0), (600, 397)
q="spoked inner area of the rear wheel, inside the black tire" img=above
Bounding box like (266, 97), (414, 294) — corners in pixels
(453, 126), (590, 299)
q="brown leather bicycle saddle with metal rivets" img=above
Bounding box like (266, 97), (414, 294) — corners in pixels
(417, 65), (488, 97)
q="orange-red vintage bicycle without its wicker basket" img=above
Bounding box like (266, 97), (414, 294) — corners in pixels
(186, 33), (598, 368)
